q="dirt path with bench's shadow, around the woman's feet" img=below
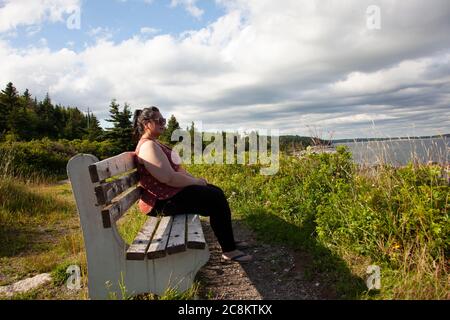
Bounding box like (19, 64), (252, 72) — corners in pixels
(198, 220), (333, 300)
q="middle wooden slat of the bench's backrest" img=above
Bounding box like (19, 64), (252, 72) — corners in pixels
(95, 171), (139, 205)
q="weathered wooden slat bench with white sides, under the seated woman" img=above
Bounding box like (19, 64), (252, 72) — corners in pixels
(67, 152), (209, 299)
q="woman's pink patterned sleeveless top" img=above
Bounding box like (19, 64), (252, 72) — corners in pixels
(135, 138), (182, 214)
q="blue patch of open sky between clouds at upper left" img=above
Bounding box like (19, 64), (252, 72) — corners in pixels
(9, 0), (224, 52)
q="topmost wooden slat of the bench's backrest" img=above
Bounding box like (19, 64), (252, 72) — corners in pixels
(89, 152), (136, 183)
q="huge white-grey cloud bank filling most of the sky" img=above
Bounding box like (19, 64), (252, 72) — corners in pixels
(0, 0), (450, 137)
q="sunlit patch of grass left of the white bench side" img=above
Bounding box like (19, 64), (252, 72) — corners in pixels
(0, 177), (86, 299)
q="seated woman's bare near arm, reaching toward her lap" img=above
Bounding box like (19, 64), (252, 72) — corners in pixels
(139, 141), (206, 187)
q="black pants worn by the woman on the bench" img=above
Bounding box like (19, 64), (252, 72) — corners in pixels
(148, 184), (236, 252)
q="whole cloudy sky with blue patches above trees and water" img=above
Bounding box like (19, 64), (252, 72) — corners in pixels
(0, 0), (450, 139)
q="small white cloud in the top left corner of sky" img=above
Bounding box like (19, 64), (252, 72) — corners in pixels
(0, 0), (81, 33)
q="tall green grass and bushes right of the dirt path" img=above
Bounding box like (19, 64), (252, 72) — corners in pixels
(185, 146), (450, 299)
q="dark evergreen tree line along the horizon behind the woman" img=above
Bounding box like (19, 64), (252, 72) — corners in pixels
(0, 82), (314, 152)
